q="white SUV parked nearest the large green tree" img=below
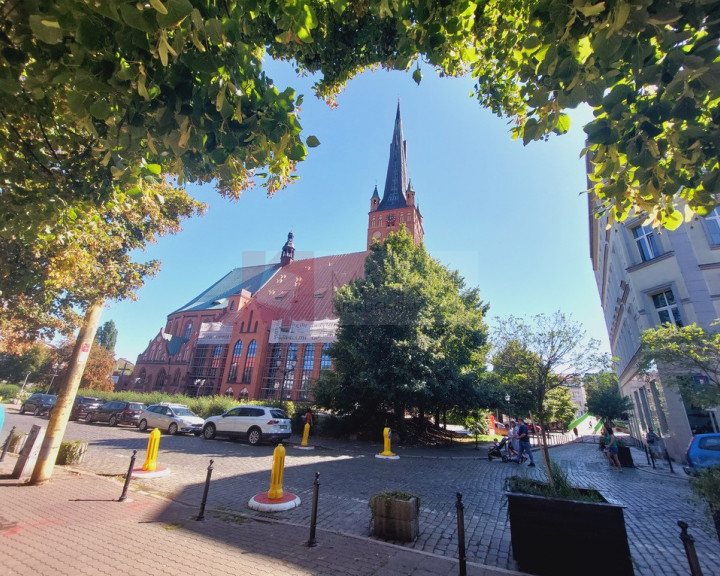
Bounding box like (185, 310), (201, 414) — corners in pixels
(202, 405), (292, 445)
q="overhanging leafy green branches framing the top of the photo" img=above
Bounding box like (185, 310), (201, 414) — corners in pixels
(0, 0), (720, 252)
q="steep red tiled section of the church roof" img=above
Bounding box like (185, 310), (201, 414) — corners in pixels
(254, 252), (368, 321)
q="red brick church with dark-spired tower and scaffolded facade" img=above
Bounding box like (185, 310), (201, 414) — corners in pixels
(118, 105), (423, 401)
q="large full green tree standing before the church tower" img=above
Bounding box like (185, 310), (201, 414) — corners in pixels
(314, 228), (487, 428)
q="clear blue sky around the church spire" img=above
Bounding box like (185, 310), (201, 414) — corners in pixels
(101, 63), (609, 362)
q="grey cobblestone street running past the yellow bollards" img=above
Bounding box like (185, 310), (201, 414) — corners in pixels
(5, 414), (720, 576)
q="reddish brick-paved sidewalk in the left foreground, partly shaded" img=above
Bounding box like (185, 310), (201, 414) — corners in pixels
(0, 454), (520, 576)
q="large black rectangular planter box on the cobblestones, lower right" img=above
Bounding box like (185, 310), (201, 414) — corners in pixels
(505, 492), (633, 576)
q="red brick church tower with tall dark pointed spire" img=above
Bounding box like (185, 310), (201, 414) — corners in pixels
(367, 102), (423, 249)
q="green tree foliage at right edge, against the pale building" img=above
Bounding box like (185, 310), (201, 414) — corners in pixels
(640, 323), (720, 408)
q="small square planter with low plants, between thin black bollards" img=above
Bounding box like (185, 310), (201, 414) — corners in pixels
(368, 490), (420, 542)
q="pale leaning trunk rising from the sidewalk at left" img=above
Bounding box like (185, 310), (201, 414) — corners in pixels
(30, 301), (103, 485)
